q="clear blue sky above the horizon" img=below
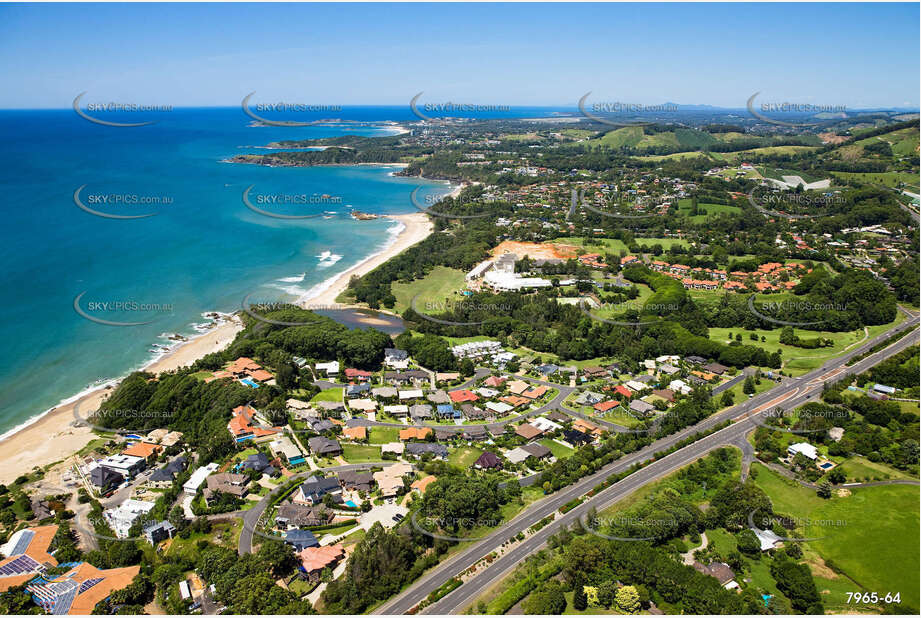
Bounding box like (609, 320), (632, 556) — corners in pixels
(0, 3), (921, 109)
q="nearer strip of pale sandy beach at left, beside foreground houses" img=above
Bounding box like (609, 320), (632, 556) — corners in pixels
(0, 318), (243, 483)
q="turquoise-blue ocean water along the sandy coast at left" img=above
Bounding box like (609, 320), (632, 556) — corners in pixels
(0, 108), (448, 433)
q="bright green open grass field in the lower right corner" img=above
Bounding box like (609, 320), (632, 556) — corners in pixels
(753, 464), (919, 610)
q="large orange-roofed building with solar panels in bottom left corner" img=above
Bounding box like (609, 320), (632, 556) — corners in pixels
(0, 526), (141, 615)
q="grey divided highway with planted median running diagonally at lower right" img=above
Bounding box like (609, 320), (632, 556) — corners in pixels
(374, 314), (918, 614)
